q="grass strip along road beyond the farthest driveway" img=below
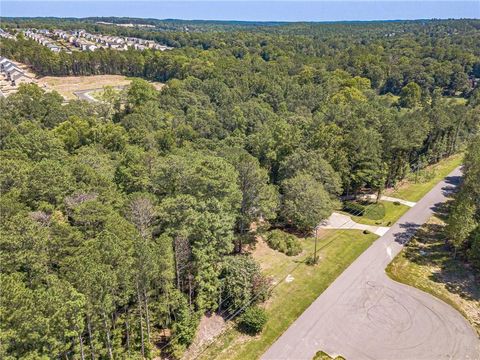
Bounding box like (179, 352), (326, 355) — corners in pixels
(385, 154), (463, 201)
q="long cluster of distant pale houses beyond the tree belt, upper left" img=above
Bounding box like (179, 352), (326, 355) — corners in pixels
(23, 29), (171, 52)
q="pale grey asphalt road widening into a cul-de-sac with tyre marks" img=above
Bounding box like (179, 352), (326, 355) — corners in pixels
(262, 169), (480, 360)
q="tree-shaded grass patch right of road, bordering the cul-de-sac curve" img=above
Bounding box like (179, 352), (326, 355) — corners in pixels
(386, 216), (480, 335)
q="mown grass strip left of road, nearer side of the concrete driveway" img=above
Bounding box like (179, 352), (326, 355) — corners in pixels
(200, 230), (377, 360)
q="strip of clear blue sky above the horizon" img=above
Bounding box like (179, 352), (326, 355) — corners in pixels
(0, 0), (480, 21)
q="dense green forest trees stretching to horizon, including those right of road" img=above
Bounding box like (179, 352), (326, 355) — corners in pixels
(0, 19), (480, 359)
